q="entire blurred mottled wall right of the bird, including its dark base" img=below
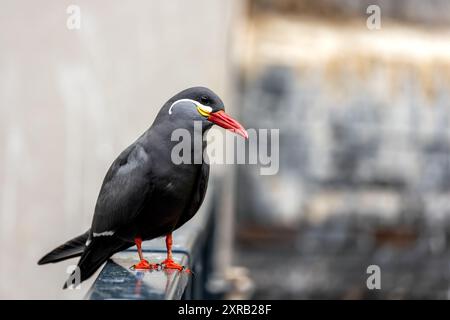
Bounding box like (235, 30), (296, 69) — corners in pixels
(237, 0), (450, 299)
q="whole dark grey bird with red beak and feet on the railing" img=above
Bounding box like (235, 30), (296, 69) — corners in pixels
(38, 87), (248, 287)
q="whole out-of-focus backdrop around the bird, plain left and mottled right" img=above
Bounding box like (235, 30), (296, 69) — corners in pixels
(0, 0), (450, 299)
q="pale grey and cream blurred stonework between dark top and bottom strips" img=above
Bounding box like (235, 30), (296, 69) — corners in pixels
(239, 5), (450, 227)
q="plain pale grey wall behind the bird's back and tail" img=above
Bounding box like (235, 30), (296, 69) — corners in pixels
(0, 0), (238, 298)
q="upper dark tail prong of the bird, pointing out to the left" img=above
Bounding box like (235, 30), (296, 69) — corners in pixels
(38, 230), (90, 265)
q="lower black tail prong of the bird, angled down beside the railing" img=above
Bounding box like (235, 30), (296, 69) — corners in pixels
(63, 236), (126, 289)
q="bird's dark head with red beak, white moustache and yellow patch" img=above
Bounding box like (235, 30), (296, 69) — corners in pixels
(166, 87), (248, 139)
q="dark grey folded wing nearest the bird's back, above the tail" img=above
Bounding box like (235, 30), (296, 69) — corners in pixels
(91, 142), (153, 236)
